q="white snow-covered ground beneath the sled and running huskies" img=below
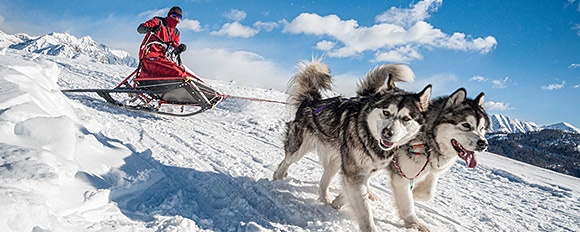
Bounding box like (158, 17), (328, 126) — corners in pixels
(0, 48), (580, 231)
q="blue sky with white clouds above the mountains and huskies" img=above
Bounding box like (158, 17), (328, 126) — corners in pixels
(0, 0), (580, 127)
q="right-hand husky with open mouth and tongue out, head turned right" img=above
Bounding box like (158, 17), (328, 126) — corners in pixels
(388, 88), (489, 231)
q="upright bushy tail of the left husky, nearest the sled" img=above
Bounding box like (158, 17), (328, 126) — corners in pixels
(288, 60), (332, 108)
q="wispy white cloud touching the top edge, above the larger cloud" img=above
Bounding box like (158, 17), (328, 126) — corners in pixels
(375, 0), (443, 27)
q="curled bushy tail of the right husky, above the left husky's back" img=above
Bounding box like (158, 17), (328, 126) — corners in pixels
(356, 64), (415, 96)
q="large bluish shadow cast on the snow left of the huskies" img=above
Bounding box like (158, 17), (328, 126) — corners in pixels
(75, 130), (346, 231)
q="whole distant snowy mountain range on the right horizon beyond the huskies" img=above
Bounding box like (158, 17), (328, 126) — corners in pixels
(489, 114), (580, 134)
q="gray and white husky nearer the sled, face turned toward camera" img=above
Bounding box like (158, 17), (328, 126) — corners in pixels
(273, 61), (431, 231)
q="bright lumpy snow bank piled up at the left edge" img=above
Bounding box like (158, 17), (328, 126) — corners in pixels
(0, 53), (131, 231)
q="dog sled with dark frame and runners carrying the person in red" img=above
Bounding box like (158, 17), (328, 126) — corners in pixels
(62, 33), (226, 117)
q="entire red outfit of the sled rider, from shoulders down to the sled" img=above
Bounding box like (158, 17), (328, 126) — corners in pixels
(139, 17), (185, 79)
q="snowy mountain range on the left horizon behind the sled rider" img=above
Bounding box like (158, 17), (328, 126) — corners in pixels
(0, 31), (138, 67)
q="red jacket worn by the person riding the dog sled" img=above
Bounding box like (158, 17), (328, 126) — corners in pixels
(139, 17), (179, 59)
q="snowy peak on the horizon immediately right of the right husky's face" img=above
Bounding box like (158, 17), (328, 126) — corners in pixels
(489, 114), (541, 133)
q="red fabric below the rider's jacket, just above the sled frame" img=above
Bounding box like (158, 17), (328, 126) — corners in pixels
(139, 57), (185, 78)
